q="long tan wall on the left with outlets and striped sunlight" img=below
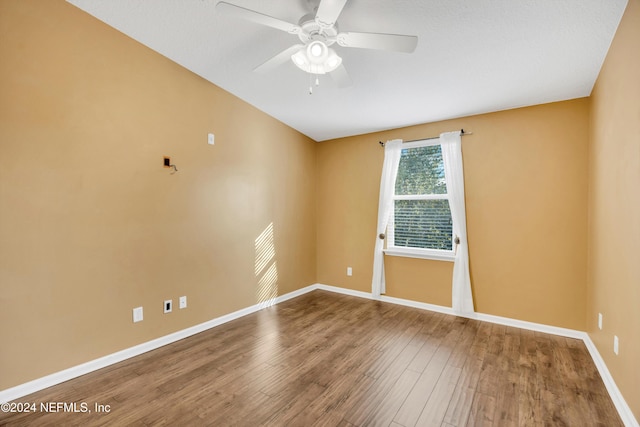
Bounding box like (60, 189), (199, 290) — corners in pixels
(0, 0), (316, 390)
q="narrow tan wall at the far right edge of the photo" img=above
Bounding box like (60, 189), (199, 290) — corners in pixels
(587, 0), (640, 420)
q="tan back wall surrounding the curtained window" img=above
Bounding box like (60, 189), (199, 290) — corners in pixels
(317, 99), (589, 330)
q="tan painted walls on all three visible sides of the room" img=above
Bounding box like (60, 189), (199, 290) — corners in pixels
(0, 0), (640, 418)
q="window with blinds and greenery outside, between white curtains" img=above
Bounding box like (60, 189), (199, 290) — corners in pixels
(385, 140), (454, 261)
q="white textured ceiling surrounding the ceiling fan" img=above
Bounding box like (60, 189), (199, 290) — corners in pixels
(68, 0), (627, 141)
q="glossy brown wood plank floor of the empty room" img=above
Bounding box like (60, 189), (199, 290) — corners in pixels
(0, 291), (622, 427)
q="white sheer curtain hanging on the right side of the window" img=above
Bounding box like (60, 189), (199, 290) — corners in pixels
(440, 131), (474, 313)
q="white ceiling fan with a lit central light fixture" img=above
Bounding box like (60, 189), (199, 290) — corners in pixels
(216, 0), (418, 92)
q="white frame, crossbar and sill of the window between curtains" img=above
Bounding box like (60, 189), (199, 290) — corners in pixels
(384, 138), (456, 262)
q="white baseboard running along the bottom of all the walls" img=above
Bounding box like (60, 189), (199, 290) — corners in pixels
(0, 283), (640, 427)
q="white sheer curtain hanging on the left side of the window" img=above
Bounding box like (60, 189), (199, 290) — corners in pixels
(371, 139), (402, 298)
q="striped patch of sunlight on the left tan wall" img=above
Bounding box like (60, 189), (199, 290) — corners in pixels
(255, 223), (278, 308)
